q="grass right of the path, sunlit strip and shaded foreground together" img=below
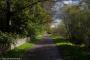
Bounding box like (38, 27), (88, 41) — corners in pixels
(53, 38), (90, 60)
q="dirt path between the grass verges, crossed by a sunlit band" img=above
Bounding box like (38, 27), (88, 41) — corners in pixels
(24, 38), (62, 60)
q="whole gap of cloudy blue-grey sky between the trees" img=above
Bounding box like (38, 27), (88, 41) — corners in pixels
(51, 0), (80, 28)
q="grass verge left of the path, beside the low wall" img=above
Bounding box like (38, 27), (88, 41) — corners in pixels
(0, 43), (34, 58)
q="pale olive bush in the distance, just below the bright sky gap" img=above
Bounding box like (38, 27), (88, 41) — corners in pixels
(51, 21), (67, 38)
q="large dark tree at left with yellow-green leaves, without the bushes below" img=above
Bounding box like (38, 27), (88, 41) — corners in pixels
(0, 0), (49, 33)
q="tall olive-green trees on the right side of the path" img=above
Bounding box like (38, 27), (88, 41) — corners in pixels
(64, 6), (90, 46)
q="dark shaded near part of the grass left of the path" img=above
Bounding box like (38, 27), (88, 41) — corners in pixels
(0, 49), (26, 58)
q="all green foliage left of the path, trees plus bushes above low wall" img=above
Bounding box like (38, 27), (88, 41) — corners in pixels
(0, 0), (51, 48)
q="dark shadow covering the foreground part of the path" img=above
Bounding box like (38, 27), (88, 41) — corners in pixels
(24, 46), (62, 60)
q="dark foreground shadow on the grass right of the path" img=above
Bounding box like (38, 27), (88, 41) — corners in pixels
(57, 45), (90, 60)
